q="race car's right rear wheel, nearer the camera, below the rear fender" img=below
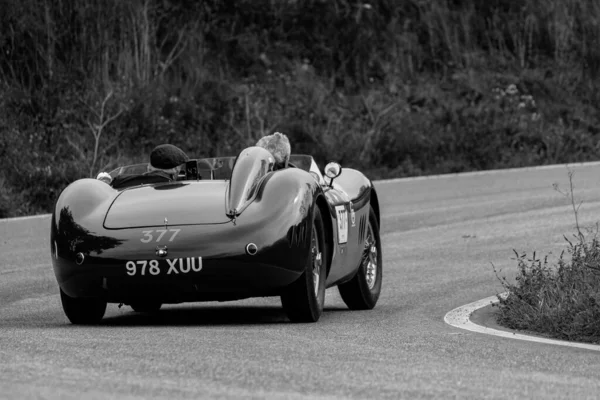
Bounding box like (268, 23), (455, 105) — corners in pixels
(281, 205), (327, 322)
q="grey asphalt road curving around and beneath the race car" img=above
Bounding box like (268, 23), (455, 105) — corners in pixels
(0, 166), (600, 399)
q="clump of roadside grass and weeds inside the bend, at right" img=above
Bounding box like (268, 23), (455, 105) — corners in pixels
(494, 172), (600, 343)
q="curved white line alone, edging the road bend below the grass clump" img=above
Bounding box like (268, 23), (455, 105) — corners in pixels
(444, 293), (600, 351)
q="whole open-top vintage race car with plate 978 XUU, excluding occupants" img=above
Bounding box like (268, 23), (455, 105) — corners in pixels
(50, 147), (382, 324)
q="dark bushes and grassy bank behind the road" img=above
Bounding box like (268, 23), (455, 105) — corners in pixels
(0, 0), (600, 217)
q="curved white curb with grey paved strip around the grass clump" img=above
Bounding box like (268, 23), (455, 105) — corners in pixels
(444, 293), (600, 351)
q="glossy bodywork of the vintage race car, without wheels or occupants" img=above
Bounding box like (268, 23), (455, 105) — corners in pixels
(50, 148), (376, 318)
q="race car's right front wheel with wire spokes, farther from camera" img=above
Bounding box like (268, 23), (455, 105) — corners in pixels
(338, 208), (383, 310)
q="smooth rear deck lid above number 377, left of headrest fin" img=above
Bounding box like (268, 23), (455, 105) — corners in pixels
(104, 181), (230, 229)
